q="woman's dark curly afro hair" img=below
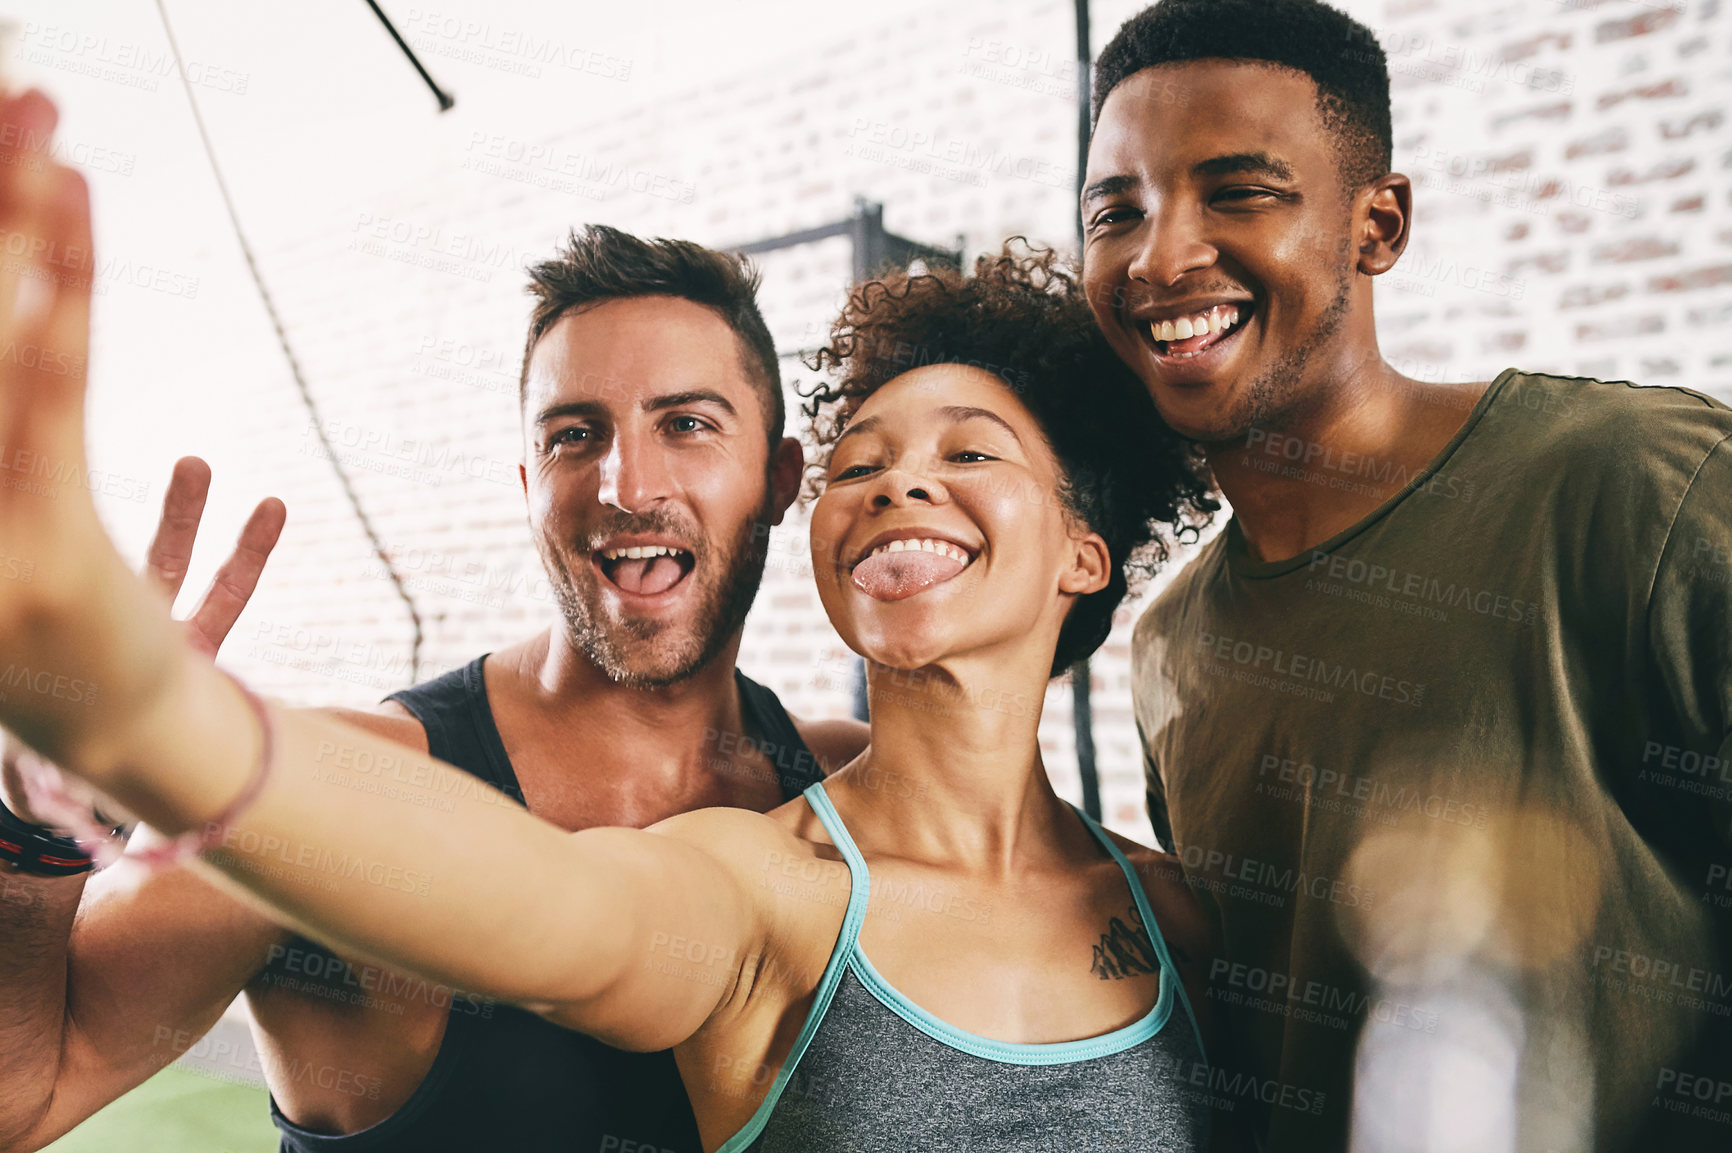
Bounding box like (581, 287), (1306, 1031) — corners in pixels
(800, 237), (1219, 677)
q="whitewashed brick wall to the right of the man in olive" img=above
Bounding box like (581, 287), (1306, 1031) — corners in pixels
(1378, 0), (1732, 398)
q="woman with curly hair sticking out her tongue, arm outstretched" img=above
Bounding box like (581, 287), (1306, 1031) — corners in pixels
(16, 225), (1214, 1153)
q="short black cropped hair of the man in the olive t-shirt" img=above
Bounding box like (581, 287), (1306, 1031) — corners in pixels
(1093, 0), (1394, 189)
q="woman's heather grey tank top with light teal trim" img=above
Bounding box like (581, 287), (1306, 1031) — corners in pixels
(717, 781), (1209, 1153)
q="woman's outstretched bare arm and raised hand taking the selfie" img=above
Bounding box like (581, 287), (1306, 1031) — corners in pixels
(0, 93), (767, 1047)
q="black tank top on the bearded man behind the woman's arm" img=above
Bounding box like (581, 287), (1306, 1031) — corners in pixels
(270, 656), (823, 1153)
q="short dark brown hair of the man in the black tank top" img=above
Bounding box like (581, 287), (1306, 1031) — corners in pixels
(518, 223), (786, 441)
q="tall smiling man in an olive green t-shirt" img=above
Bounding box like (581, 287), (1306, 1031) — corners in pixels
(1083, 0), (1732, 1153)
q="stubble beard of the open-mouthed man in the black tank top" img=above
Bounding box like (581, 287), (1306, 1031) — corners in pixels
(535, 495), (771, 689)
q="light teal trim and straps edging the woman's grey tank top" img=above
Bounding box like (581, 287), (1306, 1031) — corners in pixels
(715, 781), (1207, 1153)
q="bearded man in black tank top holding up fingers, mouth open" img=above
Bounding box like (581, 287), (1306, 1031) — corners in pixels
(0, 227), (866, 1153)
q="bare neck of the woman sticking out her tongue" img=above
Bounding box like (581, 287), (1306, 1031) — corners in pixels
(826, 650), (1088, 874)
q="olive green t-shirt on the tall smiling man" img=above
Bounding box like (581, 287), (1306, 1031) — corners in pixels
(1133, 370), (1732, 1151)
